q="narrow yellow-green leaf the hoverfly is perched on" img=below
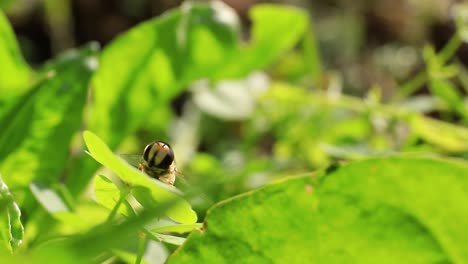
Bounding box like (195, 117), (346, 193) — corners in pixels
(83, 131), (197, 224)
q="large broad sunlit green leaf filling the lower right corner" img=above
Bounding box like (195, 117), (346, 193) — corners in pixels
(168, 157), (468, 263)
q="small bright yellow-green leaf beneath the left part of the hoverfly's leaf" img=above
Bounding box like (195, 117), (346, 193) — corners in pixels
(94, 175), (133, 216)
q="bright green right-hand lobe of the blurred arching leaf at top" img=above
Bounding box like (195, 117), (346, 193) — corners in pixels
(213, 4), (310, 79)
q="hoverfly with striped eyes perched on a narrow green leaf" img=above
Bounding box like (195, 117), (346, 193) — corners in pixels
(121, 141), (177, 185)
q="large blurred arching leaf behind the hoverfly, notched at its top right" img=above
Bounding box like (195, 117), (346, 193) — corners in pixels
(69, 2), (308, 195)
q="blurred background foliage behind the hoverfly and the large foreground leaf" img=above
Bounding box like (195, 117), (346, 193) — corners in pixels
(0, 0), (468, 259)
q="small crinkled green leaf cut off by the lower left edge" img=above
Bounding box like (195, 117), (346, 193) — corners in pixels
(0, 175), (24, 251)
